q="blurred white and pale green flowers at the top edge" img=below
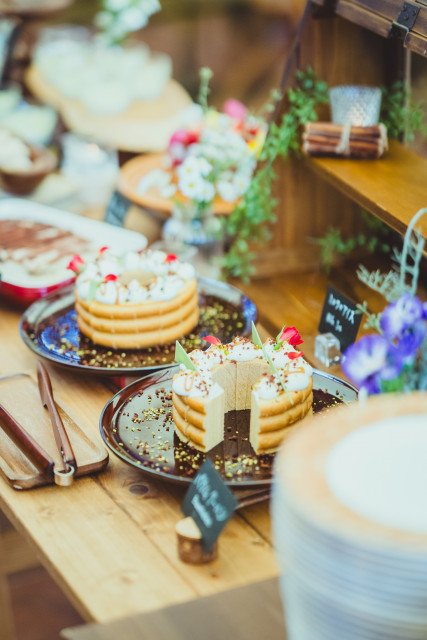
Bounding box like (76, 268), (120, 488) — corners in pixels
(95, 0), (161, 45)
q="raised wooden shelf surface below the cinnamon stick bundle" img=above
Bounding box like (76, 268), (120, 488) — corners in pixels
(306, 140), (427, 237)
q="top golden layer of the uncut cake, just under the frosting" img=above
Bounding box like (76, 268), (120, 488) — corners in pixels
(76, 278), (197, 320)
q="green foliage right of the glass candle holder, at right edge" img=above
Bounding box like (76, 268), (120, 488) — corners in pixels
(380, 81), (427, 142)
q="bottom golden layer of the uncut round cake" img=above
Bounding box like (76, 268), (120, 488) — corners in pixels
(77, 308), (199, 349)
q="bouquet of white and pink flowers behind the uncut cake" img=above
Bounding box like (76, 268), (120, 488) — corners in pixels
(138, 68), (267, 216)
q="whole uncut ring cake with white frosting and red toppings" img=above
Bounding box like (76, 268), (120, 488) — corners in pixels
(70, 248), (199, 349)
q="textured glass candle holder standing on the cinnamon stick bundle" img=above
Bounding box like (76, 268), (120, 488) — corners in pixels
(329, 85), (381, 127)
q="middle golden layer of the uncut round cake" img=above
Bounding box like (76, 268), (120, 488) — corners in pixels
(76, 293), (199, 333)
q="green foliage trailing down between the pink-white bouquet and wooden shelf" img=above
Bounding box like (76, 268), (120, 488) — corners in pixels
(223, 68), (329, 281)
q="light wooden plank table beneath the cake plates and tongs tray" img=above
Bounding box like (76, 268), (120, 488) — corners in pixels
(0, 245), (388, 636)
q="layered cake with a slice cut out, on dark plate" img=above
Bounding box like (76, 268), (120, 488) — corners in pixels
(172, 330), (313, 455)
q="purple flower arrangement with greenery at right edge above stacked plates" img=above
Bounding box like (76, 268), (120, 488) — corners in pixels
(341, 209), (427, 395)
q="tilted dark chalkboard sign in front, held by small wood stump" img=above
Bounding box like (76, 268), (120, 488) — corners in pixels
(181, 458), (237, 553)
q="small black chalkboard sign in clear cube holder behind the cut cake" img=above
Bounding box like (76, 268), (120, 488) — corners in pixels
(319, 285), (362, 353)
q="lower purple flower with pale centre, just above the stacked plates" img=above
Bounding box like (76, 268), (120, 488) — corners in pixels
(341, 334), (404, 394)
